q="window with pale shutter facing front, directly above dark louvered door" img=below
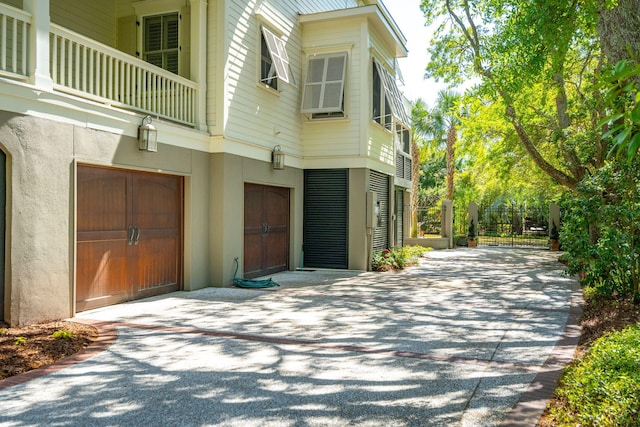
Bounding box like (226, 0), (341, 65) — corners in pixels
(302, 52), (347, 118)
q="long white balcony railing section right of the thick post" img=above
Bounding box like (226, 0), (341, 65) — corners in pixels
(50, 24), (197, 125)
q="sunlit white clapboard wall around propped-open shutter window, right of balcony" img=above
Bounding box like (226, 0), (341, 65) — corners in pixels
(222, 0), (301, 155)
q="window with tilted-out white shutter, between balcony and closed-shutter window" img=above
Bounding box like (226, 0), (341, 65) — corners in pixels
(260, 27), (291, 90)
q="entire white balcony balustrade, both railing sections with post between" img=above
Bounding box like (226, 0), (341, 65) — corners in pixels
(0, 3), (200, 127)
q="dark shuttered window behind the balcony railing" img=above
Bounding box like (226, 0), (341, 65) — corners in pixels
(143, 12), (180, 74)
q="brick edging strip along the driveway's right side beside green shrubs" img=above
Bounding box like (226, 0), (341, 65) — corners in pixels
(499, 281), (584, 427)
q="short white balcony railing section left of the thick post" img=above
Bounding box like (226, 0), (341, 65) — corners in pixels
(0, 6), (31, 80)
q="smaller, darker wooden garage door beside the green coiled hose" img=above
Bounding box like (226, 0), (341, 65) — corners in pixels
(244, 184), (289, 279)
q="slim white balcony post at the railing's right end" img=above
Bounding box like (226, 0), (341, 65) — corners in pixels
(191, 0), (208, 132)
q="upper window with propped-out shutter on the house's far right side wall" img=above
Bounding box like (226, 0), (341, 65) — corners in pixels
(372, 60), (411, 130)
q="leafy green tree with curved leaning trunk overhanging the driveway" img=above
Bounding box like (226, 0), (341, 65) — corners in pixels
(422, 0), (607, 189)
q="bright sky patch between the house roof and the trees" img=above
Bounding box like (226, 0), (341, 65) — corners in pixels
(384, 0), (446, 106)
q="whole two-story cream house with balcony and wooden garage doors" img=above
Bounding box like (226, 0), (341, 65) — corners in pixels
(0, 0), (411, 325)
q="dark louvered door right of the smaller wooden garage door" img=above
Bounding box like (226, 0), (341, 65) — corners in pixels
(303, 169), (349, 268)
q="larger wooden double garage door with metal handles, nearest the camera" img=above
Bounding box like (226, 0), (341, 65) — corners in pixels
(76, 166), (183, 311)
